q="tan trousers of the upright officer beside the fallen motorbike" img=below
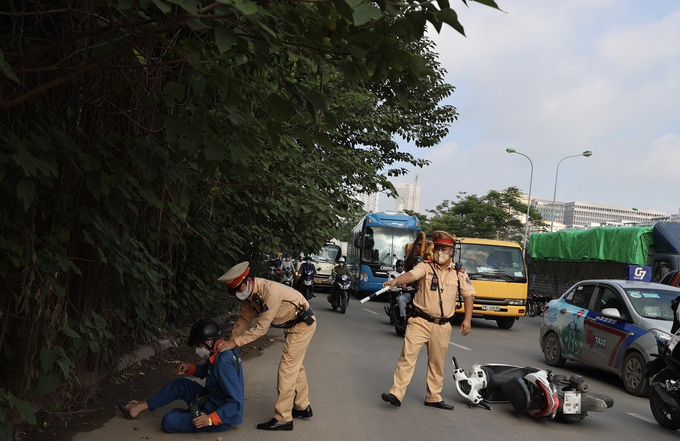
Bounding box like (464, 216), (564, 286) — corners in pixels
(390, 317), (451, 403)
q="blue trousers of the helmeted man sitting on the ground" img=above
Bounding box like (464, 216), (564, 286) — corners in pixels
(146, 378), (231, 433)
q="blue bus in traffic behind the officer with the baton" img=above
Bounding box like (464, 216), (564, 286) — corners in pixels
(347, 212), (420, 296)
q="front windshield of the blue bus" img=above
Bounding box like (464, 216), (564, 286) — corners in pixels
(361, 227), (418, 265)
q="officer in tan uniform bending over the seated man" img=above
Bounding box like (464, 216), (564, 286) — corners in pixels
(217, 262), (316, 430)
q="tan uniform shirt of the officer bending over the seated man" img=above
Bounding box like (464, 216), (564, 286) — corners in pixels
(231, 277), (309, 346)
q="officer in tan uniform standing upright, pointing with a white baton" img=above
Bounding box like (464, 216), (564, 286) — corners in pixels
(382, 231), (475, 410)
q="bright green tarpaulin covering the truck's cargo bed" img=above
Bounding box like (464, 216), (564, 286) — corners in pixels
(529, 227), (654, 265)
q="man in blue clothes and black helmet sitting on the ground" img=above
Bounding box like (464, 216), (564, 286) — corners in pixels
(117, 319), (244, 433)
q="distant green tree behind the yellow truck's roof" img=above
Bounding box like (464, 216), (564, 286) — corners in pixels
(418, 187), (545, 244)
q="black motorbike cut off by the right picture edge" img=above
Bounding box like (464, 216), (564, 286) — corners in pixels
(645, 297), (680, 430)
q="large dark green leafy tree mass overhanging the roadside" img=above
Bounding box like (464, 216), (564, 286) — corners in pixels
(0, 0), (497, 430)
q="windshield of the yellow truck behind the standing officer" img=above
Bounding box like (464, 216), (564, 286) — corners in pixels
(454, 243), (526, 279)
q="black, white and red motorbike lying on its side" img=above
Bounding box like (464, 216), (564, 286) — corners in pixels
(452, 357), (614, 423)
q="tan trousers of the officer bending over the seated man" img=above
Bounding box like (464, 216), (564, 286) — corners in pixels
(274, 316), (316, 422)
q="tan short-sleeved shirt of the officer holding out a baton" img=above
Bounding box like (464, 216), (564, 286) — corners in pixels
(410, 261), (476, 317)
